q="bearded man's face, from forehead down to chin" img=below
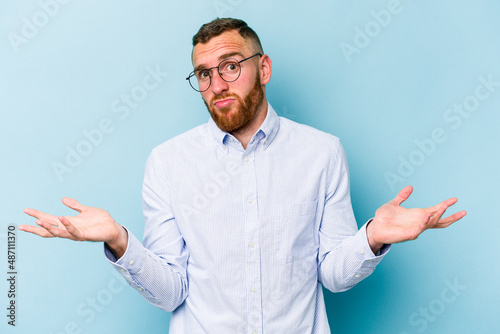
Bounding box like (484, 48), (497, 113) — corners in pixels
(193, 30), (264, 132)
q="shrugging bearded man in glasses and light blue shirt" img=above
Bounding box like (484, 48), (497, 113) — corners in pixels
(19, 19), (466, 333)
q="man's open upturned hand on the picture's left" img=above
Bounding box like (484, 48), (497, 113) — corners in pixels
(19, 197), (128, 258)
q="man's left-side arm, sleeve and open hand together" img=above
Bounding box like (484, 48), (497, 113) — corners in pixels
(19, 150), (189, 311)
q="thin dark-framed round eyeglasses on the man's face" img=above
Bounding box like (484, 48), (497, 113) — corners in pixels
(186, 53), (262, 92)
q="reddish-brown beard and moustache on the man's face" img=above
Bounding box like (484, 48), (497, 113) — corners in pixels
(203, 75), (264, 132)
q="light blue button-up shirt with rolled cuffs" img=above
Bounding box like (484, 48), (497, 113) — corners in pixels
(105, 104), (389, 334)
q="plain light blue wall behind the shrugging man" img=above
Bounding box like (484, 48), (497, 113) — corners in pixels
(0, 0), (500, 334)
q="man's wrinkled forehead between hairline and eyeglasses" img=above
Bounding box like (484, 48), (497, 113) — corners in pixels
(192, 30), (249, 68)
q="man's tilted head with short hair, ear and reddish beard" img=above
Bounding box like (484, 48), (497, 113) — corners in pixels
(192, 18), (271, 132)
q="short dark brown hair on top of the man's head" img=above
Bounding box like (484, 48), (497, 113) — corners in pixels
(193, 18), (264, 53)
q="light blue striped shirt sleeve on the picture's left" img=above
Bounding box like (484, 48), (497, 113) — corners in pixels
(105, 152), (189, 312)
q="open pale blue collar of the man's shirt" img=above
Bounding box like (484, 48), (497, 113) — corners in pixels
(208, 102), (280, 150)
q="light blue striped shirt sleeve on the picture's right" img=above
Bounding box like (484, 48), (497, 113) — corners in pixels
(318, 141), (390, 292)
